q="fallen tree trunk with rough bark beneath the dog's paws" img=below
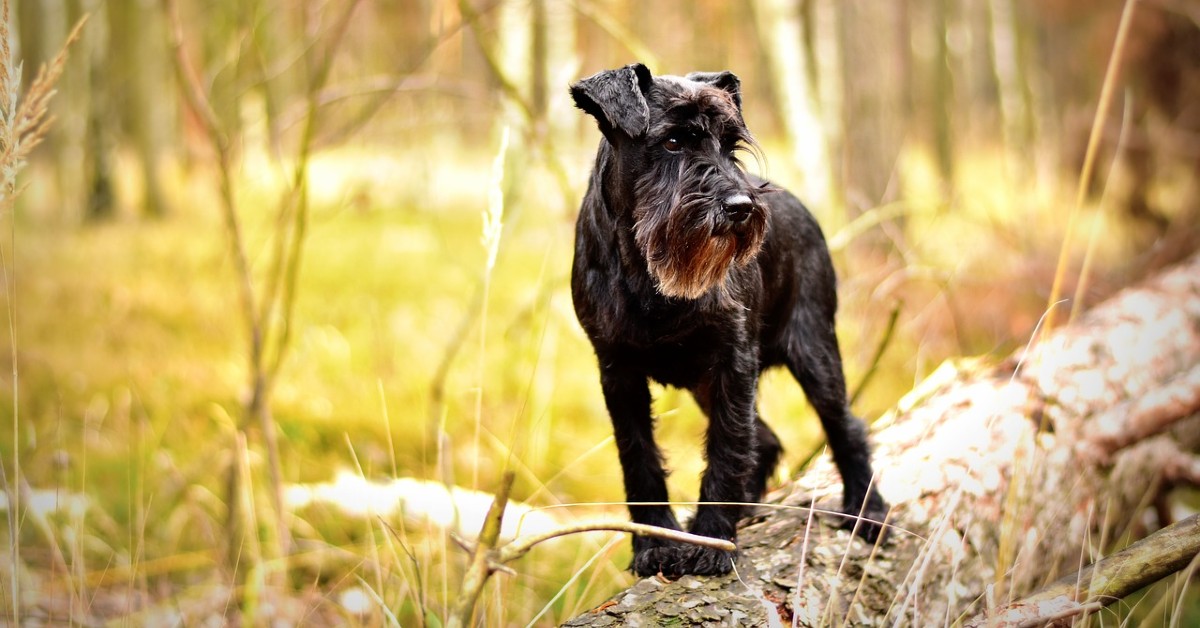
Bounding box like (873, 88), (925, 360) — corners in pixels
(568, 256), (1200, 626)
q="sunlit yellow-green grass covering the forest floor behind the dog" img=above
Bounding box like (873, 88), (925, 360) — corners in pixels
(0, 137), (1171, 626)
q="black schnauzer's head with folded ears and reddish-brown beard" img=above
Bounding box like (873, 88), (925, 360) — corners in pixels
(571, 64), (768, 299)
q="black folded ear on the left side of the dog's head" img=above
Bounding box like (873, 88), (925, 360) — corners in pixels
(571, 64), (653, 138)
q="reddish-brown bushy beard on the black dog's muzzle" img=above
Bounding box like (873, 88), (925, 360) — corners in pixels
(634, 192), (767, 299)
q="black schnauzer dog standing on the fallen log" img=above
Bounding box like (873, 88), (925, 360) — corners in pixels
(571, 64), (887, 576)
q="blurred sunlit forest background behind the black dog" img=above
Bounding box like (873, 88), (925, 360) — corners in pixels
(7, 0), (1200, 626)
